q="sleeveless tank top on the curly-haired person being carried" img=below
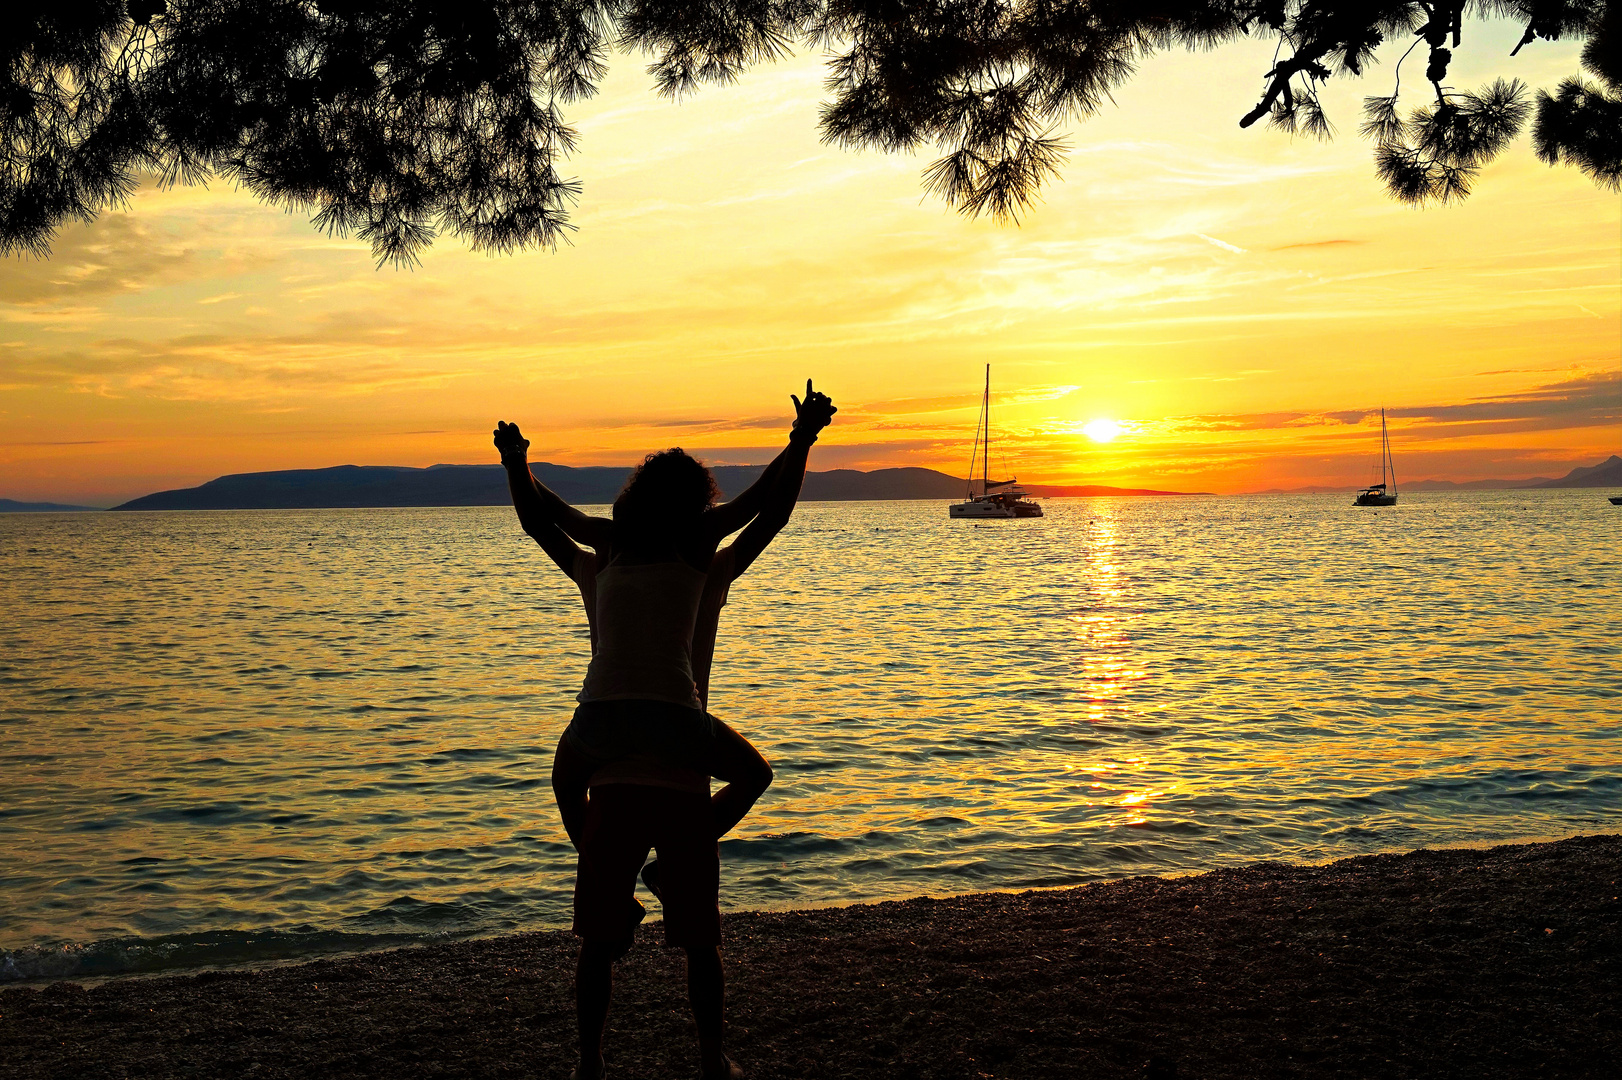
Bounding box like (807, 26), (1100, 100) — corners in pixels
(579, 563), (707, 709)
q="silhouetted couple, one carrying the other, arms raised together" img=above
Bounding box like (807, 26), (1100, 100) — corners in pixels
(495, 379), (837, 1080)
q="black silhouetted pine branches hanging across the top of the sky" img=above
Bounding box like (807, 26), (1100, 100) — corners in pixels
(0, 0), (1622, 263)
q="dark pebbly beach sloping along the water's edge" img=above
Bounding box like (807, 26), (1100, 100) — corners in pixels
(0, 835), (1622, 1080)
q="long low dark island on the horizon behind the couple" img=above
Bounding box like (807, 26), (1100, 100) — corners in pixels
(114, 462), (1206, 511)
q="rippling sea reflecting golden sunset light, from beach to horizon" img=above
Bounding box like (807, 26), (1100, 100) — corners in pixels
(0, 491), (1622, 979)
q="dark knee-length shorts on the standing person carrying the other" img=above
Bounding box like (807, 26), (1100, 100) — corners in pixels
(574, 783), (720, 949)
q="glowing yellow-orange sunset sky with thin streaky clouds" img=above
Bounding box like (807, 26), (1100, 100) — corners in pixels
(0, 16), (1622, 504)
